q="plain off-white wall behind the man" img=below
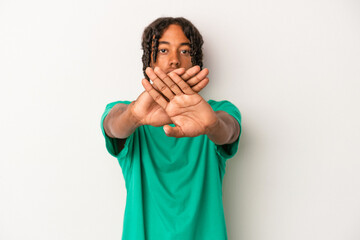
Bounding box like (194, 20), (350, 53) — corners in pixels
(0, 0), (360, 240)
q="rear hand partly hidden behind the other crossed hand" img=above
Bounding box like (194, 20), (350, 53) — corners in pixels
(131, 66), (209, 127)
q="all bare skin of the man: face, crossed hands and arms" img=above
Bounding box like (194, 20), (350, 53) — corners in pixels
(104, 25), (240, 149)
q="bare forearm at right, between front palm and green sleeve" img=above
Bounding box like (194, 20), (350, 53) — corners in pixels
(206, 111), (240, 145)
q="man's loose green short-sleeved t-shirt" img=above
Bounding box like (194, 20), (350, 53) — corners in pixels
(101, 100), (241, 240)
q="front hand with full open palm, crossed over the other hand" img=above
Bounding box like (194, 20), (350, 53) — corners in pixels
(142, 68), (218, 137)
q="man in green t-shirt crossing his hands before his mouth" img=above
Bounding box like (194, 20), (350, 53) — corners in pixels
(101, 18), (241, 240)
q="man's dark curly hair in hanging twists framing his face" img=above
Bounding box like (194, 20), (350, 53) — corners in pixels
(141, 17), (204, 80)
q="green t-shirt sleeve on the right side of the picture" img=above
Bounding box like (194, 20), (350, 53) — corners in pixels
(209, 100), (241, 160)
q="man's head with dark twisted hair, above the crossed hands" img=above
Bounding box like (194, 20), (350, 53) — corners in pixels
(142, 17), (203, 79)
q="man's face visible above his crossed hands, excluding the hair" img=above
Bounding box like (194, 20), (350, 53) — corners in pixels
(150, 24), (192, 73)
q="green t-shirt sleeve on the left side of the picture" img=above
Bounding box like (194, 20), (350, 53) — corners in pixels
(100, 101), (131, 158)
